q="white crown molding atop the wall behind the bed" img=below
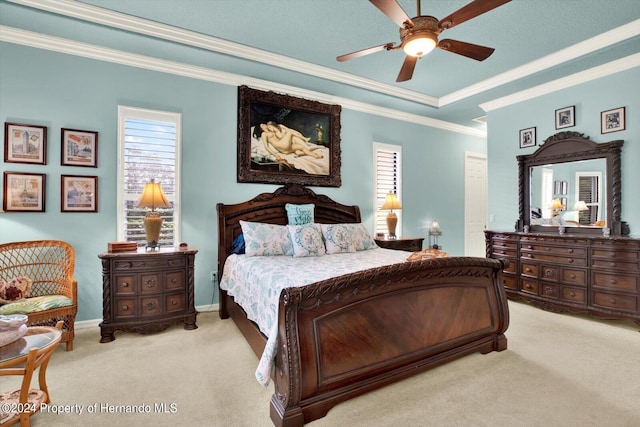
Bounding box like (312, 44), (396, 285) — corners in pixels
(0, 25), (487, 138)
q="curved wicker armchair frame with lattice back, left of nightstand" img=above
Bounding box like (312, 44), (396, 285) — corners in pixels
(0, 240), (78, 351)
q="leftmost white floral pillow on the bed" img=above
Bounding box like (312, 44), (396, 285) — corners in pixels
(240, 221), (293, 256)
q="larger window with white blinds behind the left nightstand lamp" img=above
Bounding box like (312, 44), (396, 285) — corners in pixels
(118, 106), (182, 246)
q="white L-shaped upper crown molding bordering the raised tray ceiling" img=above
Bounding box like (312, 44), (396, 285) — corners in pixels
(7, 0), (640, 113)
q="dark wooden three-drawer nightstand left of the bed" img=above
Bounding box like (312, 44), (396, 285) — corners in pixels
(99, 248), (198, 343)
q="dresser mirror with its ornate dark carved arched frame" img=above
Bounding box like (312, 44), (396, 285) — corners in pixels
(516, 132), (629, 235)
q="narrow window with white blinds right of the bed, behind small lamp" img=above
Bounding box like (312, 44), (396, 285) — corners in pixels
(373, 142), (402, 235)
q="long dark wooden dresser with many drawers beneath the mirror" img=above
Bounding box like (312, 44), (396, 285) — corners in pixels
(485, 231), (640, 325)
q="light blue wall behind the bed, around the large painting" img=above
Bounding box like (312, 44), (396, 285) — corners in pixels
(0, 43), (486, 320)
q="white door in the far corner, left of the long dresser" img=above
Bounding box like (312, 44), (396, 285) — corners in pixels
(464, 152), (487, 258)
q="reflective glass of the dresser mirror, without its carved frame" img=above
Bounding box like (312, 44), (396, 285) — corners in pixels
(529, 159), (607, 227)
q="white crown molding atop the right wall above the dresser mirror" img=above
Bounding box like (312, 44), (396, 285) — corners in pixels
(480, 53), (640, 112)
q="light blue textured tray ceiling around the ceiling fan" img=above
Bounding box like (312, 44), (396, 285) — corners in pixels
(10, 0), (640, 127)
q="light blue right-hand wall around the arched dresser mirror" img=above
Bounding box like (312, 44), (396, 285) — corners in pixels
(487, 67), (640, 236)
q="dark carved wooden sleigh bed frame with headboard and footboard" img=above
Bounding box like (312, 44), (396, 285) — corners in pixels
(217, 185), (509, 426)
